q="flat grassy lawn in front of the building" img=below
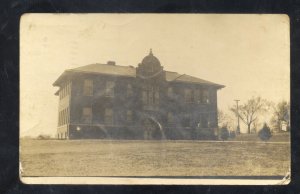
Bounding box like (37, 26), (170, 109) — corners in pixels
(20, 133), (290, 176)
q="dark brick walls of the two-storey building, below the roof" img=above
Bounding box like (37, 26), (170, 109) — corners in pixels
(58, 71), (217, 139)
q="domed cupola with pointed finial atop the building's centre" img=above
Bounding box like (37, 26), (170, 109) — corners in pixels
(137, 49), (163, 78)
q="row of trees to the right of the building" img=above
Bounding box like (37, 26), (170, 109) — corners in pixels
(218, 96), (290, 134)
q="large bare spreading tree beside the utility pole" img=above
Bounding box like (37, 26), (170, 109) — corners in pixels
(230, 97), (269, 134)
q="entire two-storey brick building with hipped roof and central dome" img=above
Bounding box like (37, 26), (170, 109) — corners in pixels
(53, 51), (224, 139)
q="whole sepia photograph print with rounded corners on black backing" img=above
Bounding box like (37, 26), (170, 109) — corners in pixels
(19, 13), (293, 185)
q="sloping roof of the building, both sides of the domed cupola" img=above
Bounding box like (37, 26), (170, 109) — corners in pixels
(53, 63), (224, 88)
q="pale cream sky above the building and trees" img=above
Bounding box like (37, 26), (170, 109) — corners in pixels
(20, 14), (290, 136)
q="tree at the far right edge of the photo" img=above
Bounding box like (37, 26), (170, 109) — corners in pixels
(271, 100), (290, 131)
